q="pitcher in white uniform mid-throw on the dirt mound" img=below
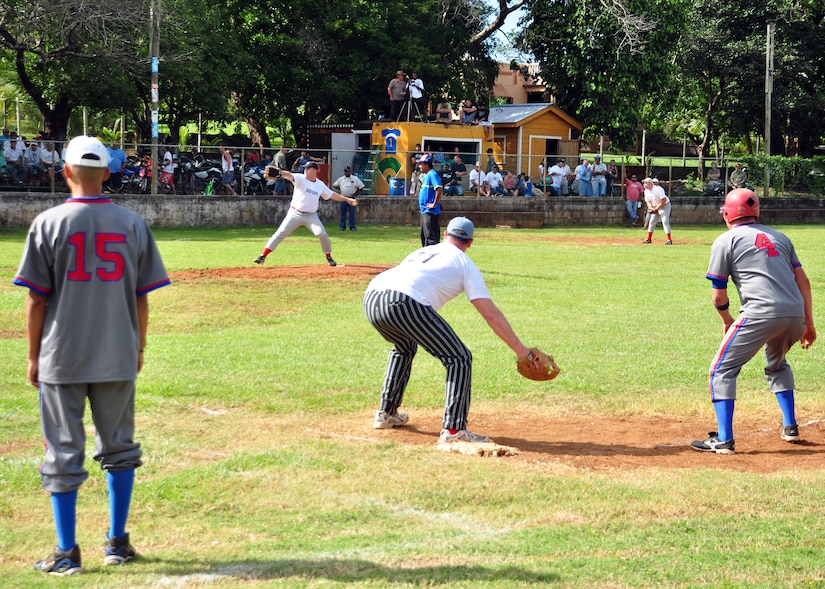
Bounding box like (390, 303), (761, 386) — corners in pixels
(254, 162), (358, 266)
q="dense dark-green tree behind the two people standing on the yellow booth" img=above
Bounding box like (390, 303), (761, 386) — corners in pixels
(222, 0), (496, 147)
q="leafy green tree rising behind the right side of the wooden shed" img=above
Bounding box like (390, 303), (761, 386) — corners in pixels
(517, 0), (687, 147)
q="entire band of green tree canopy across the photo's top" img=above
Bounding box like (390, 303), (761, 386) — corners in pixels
(0, 0), (825, 155)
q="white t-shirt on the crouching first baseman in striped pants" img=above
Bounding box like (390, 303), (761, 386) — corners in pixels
(367, 241), (490, 311)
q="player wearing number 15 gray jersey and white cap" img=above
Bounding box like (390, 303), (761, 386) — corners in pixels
(14, 136), (170, 575)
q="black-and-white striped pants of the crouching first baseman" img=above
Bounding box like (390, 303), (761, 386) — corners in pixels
(364, 290), (473, 429)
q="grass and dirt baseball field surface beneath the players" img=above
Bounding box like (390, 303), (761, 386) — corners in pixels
(0, 220), (825, 589)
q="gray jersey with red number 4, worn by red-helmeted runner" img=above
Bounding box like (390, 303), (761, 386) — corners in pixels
(707, 223), (805, 318)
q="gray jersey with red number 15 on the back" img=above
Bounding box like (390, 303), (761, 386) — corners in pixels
(14, 197), (170, 384)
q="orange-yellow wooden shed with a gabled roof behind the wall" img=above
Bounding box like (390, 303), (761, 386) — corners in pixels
(490, 103), (582, 176)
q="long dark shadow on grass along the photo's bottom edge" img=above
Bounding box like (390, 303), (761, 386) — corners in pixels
(140, 557), (561, 587)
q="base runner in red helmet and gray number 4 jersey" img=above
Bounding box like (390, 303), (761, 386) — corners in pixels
(692, 188), (816, 454)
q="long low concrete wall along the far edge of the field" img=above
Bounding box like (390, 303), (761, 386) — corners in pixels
(0, 193), (825, 228)
